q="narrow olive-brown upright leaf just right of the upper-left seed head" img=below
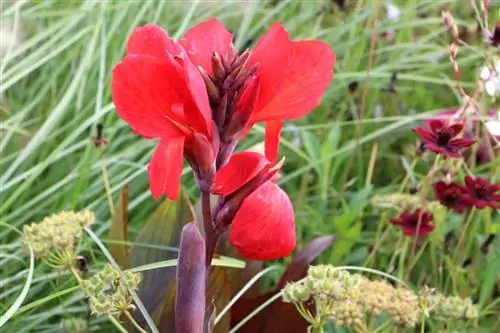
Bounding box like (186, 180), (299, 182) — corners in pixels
(108, 185), (130, 268)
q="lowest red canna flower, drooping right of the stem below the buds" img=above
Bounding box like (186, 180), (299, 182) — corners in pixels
(212, 152), (296, 260)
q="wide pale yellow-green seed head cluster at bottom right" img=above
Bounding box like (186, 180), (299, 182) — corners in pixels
(283, 265), (477, 328)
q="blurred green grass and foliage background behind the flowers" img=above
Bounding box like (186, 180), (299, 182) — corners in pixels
(0, 0), (500, 333)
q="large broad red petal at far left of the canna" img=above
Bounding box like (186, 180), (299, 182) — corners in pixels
(112, 55), (211, 137)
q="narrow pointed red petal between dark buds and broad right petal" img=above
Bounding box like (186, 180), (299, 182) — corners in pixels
(247, 23), (292, 110)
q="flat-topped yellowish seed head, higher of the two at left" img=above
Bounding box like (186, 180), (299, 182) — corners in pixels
(23, 211), (94, 258)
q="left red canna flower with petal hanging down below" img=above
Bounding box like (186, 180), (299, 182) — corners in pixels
(112, 25), (219, 200)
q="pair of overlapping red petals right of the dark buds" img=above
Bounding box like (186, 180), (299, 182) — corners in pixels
(249, 24), (335, 122)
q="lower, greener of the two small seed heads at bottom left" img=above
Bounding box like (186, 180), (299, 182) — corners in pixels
(82, 264), (141, 316)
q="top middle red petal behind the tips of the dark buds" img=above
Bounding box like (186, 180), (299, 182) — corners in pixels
(179, 19), (233, 73)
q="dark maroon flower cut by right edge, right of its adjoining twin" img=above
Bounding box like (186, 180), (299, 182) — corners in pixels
(464, 176), (500, 209)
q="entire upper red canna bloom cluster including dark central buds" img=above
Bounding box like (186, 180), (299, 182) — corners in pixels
(112, 19), (335, 199)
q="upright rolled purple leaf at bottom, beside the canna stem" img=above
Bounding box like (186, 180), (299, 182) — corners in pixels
(175, 222), (206, 333)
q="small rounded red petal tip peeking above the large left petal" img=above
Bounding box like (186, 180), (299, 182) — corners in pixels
(127, 24), (182, 58)
